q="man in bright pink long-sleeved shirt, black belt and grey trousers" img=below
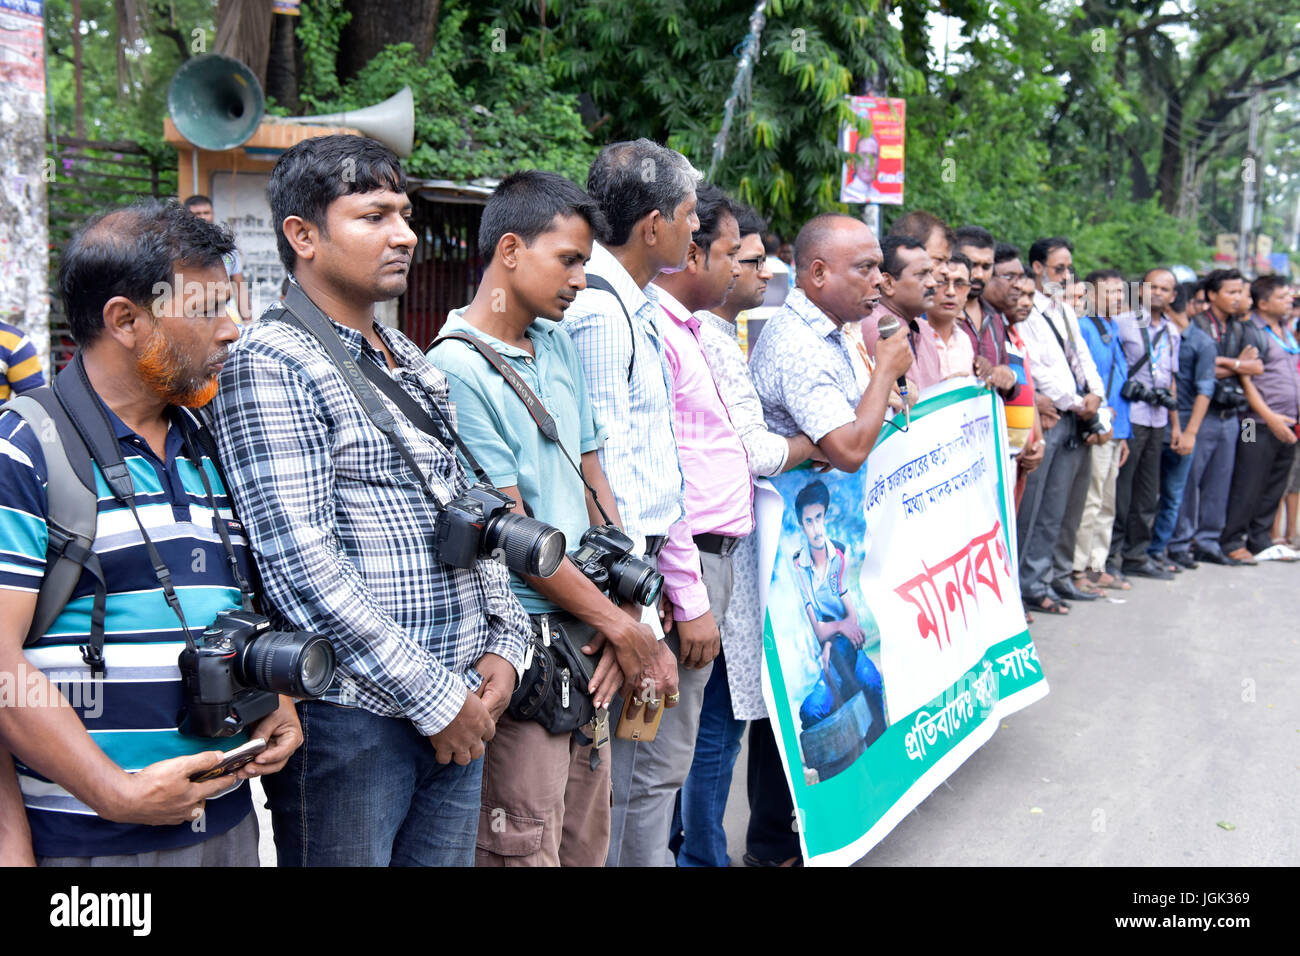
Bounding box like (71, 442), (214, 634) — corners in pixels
(628, 180), (754, 866)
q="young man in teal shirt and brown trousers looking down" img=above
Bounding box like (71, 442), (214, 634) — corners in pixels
(429, 172), (660, 866)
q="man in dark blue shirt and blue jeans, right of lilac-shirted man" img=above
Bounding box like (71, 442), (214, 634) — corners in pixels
(1148, 289), (1218, 570)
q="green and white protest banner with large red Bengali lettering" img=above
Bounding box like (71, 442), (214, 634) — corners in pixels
(755, 378), (1048, 865)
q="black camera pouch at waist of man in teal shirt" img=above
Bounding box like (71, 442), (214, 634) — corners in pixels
(507, 614), (599, 734)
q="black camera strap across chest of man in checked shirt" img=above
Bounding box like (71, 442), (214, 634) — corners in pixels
(276, 282), (491, 511)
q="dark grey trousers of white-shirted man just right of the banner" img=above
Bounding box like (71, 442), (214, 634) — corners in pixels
(1015, 412), (1089, 601)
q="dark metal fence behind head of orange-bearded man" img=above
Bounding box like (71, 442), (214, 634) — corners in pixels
(46, 137), (177, 369)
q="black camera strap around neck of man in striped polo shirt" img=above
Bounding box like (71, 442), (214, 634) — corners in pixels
(53, 352), (252, 675)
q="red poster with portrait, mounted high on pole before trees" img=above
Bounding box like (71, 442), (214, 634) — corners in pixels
(840, 96), (907, 206)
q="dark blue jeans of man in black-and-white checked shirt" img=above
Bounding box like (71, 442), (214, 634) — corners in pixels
(263, 701), (484, 866)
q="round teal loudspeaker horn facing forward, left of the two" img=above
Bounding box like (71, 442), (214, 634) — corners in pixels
(166, 53), (267, 151)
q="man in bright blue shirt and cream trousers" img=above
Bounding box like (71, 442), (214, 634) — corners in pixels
(1066, 269), (1132, 591)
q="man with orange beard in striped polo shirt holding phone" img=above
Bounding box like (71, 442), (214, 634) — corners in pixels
(0, 202), (302, 866)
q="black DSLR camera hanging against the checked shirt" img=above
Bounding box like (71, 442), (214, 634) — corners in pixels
(433, 483), (566, 578)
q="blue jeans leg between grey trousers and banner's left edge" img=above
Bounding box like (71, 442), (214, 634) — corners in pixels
(670, 654), (746, 866)
